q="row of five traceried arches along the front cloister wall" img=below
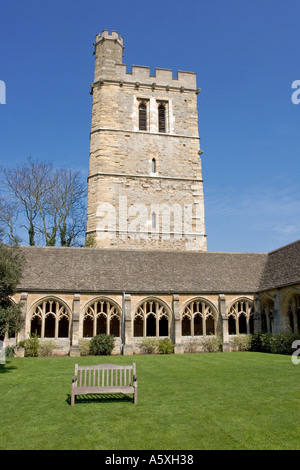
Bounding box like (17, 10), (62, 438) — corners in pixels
(19, 295), (254, 349)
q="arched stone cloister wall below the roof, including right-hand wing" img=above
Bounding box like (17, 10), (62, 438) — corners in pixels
(7, 282), (300, 353)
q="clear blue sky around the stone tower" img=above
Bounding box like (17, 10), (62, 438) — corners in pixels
(0, 0), (300, 252)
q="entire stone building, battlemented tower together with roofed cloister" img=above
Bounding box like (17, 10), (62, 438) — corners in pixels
(10, 31), (300, 355)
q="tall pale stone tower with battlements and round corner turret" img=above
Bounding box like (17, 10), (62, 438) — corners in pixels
(87, 30), (206, 251)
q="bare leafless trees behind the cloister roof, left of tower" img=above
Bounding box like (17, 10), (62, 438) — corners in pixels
(0, 157), (86, 246)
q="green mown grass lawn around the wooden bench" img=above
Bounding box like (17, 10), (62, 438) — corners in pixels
(0, 352), (300, 450)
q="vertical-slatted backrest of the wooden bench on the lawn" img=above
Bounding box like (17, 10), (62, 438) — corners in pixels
(75, 364), (136, 387)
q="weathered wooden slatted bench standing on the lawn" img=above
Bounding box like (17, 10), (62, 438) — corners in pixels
(71, 363), (137, 406)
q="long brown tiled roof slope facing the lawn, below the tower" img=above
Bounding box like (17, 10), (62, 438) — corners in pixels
(18, 247), (267, 293)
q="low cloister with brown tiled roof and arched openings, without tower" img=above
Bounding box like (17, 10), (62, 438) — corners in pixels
(15, 241), (300, 354)
